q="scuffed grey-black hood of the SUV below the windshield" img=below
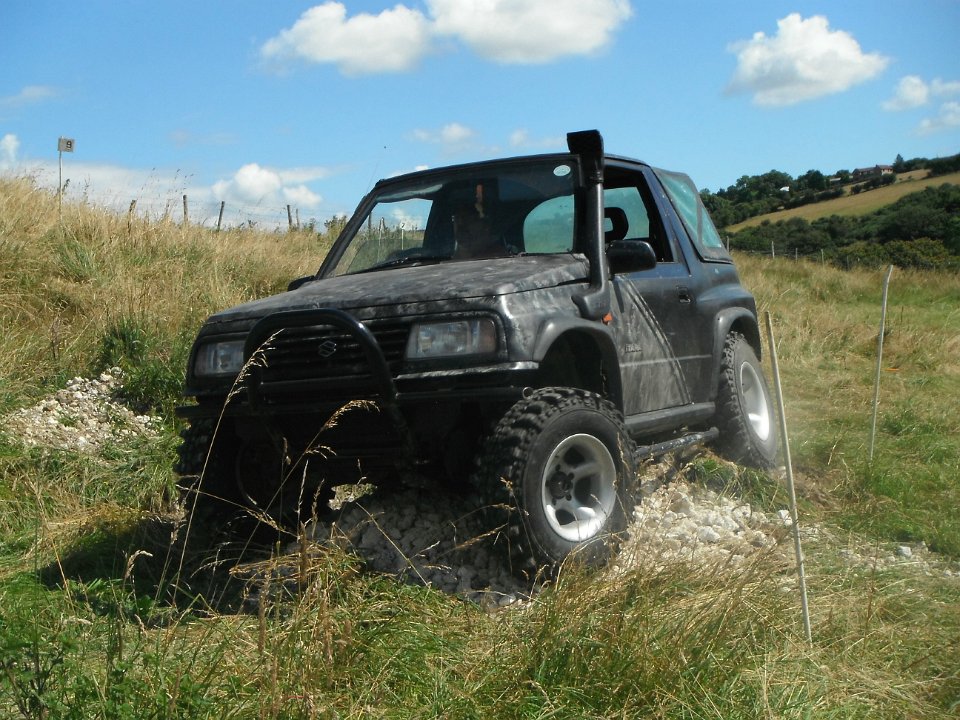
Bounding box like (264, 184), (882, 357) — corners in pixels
(210, 254), (589, 322)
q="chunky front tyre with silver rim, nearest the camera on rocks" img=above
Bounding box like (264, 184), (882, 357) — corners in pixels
(481, 388), (636, 574)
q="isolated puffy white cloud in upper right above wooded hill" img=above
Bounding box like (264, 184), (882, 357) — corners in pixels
(727, 13), (890, 107)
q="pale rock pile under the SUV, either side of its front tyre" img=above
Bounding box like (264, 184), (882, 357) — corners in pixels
(289, 482), (789, 607)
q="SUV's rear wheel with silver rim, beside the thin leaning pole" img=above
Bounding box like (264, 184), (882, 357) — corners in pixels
(716, 332), (777, 469)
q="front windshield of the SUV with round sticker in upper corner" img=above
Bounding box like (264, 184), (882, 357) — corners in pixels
(330, 156), (578, 275)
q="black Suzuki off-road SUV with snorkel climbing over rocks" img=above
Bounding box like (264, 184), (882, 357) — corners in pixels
(178, 131), (777, 564)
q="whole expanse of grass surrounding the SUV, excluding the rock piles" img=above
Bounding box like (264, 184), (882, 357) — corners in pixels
(0, 178), (960, 720)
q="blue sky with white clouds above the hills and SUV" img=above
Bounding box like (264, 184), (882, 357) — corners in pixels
(0, 0), (960, 226)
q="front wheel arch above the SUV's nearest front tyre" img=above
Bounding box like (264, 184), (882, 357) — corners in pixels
(533, 319), (623, 412)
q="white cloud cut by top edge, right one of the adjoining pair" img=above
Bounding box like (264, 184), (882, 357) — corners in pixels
(427, 0), (633, 63)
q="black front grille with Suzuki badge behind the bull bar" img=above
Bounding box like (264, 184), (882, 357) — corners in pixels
(259, 320), (410, 400)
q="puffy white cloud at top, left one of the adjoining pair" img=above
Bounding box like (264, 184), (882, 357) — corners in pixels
(260, 2), (429, 75)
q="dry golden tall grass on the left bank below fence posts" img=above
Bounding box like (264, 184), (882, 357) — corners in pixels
(0, 178), (331, 402)
